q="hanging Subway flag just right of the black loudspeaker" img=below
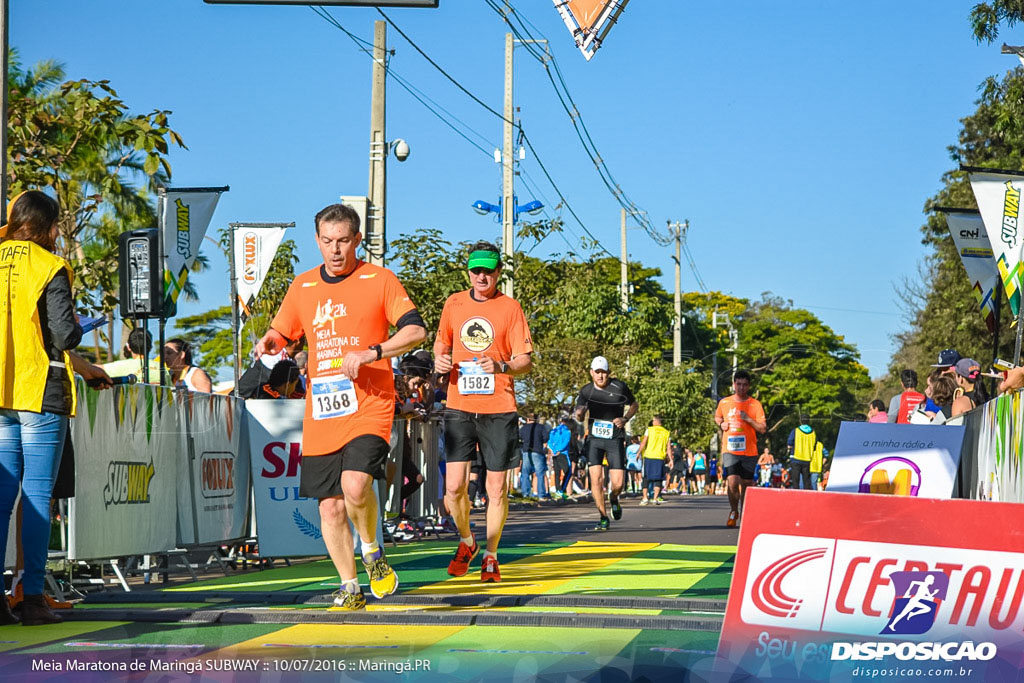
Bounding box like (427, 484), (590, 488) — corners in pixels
(159, 187), (227, 302)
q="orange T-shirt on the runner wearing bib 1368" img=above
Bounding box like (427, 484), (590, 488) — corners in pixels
(270, 261), (416, 456)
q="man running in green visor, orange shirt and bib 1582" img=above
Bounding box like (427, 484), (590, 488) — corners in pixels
(434, 242), (534, 582)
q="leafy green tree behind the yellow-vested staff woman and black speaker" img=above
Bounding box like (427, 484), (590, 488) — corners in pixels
(7, 51), (184, 362)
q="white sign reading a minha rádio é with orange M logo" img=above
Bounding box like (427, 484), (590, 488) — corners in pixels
(827, 422), (964, 498)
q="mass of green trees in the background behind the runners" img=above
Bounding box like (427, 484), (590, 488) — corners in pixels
(390, 229), (870, 454)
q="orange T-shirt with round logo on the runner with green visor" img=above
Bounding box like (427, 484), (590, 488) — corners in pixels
(437, 290), (534, 415)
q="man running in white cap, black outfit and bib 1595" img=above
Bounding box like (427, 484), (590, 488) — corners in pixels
(577, 355), (639, 531)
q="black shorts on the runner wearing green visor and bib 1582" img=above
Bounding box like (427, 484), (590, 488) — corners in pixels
(444, 410), (519, 472)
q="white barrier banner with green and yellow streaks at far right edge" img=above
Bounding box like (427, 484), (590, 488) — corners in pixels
(970, 392), (1024, 503)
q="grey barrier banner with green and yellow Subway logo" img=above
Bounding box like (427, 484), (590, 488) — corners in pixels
(68, 383), (183, 559)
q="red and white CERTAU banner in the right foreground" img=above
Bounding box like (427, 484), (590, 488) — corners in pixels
(716, 487), (1024, 681)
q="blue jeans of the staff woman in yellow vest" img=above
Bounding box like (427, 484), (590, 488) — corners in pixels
(0, 409), (68, 595)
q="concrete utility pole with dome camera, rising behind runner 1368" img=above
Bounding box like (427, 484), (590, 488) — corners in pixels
(365, 22), (388, 265)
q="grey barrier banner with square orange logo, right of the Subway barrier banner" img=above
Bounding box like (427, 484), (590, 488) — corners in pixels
(177, 392), (250, 545)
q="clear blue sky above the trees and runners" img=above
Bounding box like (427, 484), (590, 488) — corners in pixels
(10, 0), (1016, 376)
